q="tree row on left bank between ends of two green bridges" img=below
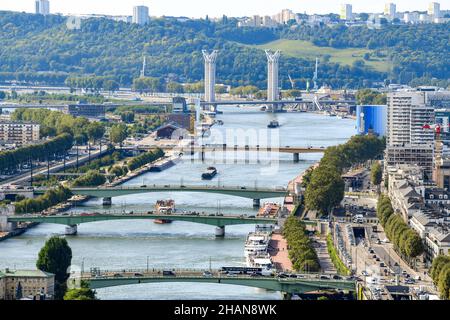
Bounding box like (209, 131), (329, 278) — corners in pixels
(15, 186), (72, 214)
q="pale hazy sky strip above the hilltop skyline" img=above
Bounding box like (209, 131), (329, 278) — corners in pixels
(0, 0), (450, 17)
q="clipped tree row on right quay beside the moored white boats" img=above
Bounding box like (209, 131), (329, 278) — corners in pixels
(283, 215), (320, 272)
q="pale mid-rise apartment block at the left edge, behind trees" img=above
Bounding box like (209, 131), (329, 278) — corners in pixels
(0, 121), (40, 145)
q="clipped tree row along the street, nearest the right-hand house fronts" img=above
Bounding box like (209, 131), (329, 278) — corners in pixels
(377, 195), (424, 260)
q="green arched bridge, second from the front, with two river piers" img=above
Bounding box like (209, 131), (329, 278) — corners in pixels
(7, 212), (282, 237)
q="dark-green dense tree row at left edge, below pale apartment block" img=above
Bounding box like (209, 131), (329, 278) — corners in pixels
(0, 133), (73, 172)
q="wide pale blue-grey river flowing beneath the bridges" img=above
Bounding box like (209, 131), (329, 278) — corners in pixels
(0, 107), (355, 299)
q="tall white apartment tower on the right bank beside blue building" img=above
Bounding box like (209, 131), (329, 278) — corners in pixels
(386, 91), (435, 179)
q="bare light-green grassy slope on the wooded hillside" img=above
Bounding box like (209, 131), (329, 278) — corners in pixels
(252, 39), (392, 72)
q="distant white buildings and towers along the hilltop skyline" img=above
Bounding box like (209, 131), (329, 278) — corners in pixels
(31, 0), (450, 28)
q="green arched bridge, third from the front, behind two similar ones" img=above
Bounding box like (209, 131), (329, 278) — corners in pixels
(33, 185), (287, 207)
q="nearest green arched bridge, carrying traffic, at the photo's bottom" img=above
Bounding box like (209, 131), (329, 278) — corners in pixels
(68, 269), (356, 295)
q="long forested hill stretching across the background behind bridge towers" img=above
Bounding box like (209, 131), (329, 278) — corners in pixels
(0, 12), (450, 88)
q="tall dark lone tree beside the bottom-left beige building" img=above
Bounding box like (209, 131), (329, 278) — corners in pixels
(36, 236), (72, 300)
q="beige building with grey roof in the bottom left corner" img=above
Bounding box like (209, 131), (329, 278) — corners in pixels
(0, 269), (55, 300)
